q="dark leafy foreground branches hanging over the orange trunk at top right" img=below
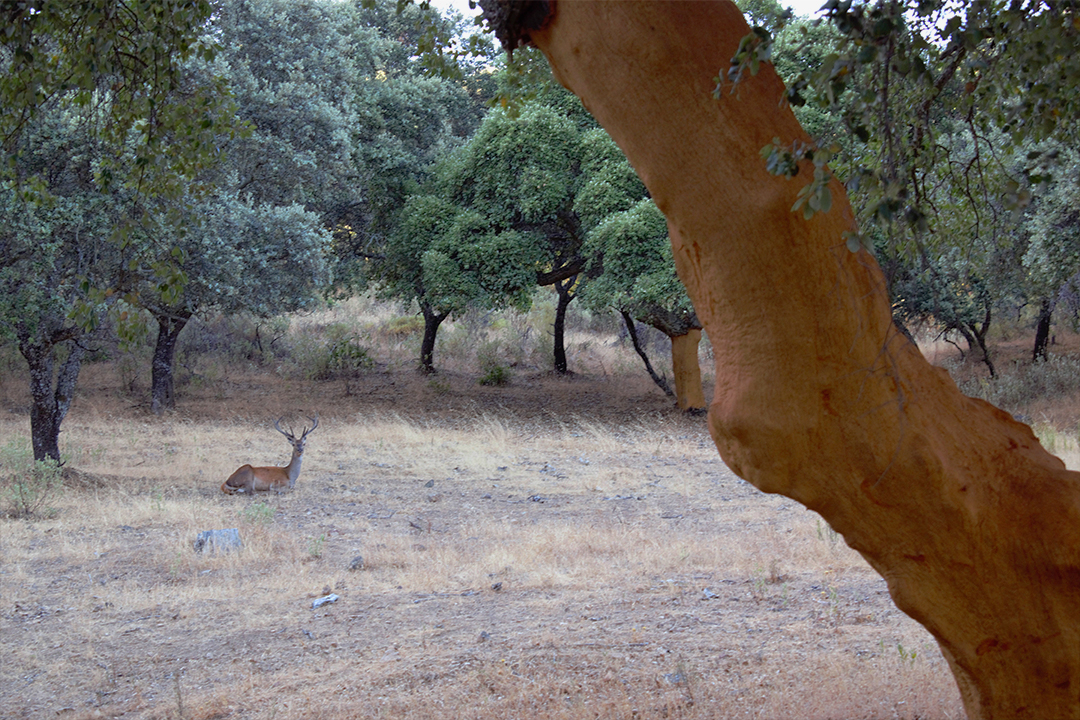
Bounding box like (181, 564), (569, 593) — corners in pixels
(733, 0), (1080, 243)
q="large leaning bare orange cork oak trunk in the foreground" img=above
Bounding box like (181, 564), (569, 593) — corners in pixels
(518, 0), (1080, 718)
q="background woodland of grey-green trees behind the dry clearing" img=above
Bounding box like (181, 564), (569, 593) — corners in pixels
(0, 0), (1080, 468)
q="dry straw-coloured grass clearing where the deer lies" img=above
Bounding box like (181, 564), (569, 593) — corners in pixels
(0, 343), (976, 720)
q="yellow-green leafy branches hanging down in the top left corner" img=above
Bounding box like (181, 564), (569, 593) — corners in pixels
(0, 0), (230, 201)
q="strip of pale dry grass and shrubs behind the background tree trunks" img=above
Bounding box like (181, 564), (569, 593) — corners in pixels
(88, 290), (695, 397)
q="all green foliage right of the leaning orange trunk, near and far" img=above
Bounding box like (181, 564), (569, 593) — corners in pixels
(721, 0), (1080, 349)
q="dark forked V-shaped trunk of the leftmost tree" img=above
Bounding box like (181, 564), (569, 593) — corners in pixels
(16, 327), (86, 462)
